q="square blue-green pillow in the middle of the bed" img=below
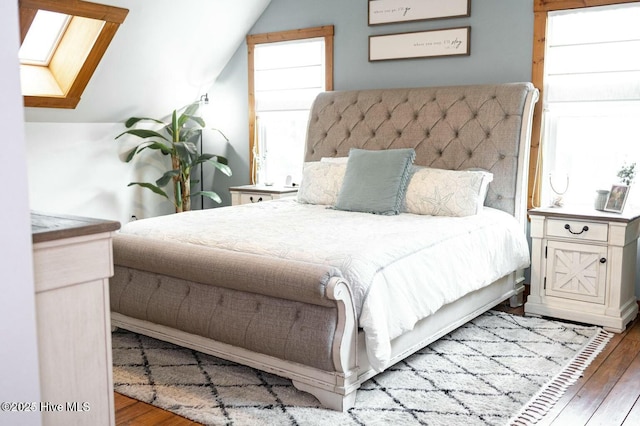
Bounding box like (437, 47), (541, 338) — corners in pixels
(335, 148), (416, 215)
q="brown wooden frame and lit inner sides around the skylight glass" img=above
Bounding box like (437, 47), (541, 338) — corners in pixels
(19, 0), (129, 108)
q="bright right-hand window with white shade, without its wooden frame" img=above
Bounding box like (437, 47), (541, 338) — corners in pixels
(541, 4), (640, 209)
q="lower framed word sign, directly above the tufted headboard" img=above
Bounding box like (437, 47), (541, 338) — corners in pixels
(369, 27), (471, 62)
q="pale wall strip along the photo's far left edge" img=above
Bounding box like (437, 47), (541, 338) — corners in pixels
(0, 1), (41, 425)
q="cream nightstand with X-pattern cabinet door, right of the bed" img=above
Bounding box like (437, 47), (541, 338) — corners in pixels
(524, 208), (640, 332)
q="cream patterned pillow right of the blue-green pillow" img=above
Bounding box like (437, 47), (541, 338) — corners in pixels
(405, 167), (493, 217)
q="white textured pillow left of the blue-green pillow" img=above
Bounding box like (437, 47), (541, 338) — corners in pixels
(298, 161), (347, 206)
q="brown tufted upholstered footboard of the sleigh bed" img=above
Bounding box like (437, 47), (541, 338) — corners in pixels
(110, 235), (357, 410)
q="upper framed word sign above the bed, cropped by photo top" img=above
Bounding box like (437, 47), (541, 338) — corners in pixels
(369, 0), (471, 25)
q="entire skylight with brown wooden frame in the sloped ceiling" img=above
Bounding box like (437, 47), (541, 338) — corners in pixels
(19, 0), (128, 108)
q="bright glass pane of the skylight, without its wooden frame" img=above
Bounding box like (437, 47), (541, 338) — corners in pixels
(18, 10), (71, 66)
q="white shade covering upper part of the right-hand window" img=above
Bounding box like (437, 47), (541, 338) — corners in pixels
(545, 5), (640, 104)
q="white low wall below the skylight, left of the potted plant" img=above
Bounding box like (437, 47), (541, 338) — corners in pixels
(26, 123), (173, 223)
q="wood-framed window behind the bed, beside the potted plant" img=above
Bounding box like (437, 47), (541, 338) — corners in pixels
(247, 26), (333, 185)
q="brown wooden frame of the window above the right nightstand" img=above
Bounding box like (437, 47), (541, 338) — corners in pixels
(528, 0), (638, 208)
